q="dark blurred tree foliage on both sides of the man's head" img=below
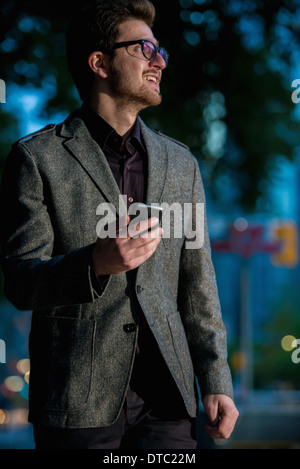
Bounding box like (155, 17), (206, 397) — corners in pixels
(0, 0), (300, 211)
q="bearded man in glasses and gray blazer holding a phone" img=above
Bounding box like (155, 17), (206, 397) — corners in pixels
(2, 0), (238, 449)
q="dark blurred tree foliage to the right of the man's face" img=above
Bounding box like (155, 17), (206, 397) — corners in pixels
(150, 0), (300, 213)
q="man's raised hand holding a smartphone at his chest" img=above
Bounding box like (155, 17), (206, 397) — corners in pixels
(92, 216), (162, 277)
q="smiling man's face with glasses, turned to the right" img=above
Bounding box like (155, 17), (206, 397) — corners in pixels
(109, 19), (166, 111)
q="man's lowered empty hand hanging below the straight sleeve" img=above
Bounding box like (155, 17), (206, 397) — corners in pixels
(203, 394), (239, 439)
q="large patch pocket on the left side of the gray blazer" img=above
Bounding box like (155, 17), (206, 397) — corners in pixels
(32, 317), (96, 411)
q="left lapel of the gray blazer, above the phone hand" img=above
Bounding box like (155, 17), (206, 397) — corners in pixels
(61, 111), (127, 216)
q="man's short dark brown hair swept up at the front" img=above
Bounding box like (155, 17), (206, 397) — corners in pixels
(66, 0), (155, 100)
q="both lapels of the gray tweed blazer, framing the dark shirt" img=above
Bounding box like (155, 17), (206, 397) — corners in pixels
(60, 109), (168, 210)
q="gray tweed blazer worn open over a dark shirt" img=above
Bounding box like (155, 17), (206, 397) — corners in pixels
(1, 110), (232, 428)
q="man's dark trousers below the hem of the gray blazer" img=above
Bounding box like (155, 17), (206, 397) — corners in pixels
(34, 390), (196, 449)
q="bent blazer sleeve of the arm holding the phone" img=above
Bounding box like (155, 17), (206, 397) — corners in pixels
(0, 144), (108, 310)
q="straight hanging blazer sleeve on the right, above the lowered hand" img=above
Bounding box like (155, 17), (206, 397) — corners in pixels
(178, 156), (233, 398)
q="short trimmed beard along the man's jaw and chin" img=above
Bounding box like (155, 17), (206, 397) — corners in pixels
(110, 62), (162, 111)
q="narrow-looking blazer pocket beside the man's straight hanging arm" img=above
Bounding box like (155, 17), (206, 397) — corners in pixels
(167, 311), (194, 391)
